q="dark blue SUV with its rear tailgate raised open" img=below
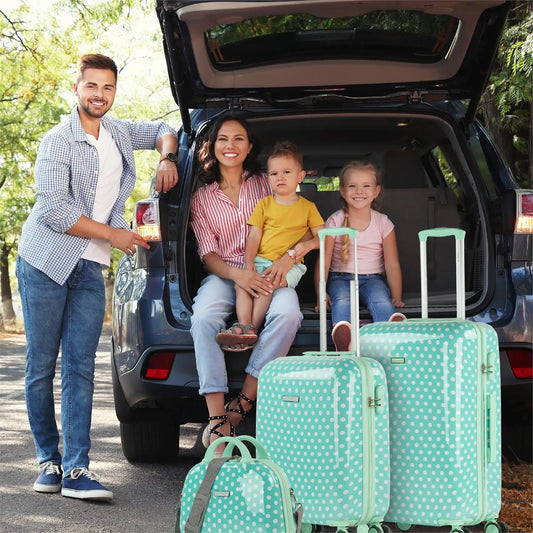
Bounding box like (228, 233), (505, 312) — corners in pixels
(112, 0), (533, 461)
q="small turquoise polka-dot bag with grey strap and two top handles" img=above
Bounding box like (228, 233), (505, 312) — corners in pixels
(176, 435), (302, 533)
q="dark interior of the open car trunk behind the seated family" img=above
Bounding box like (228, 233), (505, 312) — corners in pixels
(177, 107), (495, 331)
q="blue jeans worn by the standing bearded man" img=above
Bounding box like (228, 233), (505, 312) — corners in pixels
(17, 257), (105, 476)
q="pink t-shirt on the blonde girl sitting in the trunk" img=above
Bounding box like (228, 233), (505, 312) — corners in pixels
(326, 209), (394, 274)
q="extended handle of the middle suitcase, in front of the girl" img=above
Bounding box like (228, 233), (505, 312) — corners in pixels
(318, 227), (360, 356)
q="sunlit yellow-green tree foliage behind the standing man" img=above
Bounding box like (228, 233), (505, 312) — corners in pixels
(0, 0), (179, 329)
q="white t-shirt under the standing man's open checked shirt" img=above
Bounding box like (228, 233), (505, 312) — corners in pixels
(82, 125), (123, 267)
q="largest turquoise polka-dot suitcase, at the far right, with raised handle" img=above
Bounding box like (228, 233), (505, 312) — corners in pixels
(360, 228), (506, 533)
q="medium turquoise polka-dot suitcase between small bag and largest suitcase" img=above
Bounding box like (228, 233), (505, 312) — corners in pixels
(256, 228), (389, 533)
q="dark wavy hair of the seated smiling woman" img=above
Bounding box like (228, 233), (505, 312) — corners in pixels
(198, 114), (261, 183)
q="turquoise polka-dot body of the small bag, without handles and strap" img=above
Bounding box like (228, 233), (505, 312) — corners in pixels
(180, 461), (295, 533)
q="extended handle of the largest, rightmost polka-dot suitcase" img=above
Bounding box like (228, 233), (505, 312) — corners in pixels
(418, 228), (466, 320)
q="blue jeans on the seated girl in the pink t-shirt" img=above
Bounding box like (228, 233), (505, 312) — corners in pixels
(327, 272), (396, 324)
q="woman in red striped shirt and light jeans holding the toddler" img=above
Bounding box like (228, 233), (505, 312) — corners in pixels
(191, 115), (303, 446)
